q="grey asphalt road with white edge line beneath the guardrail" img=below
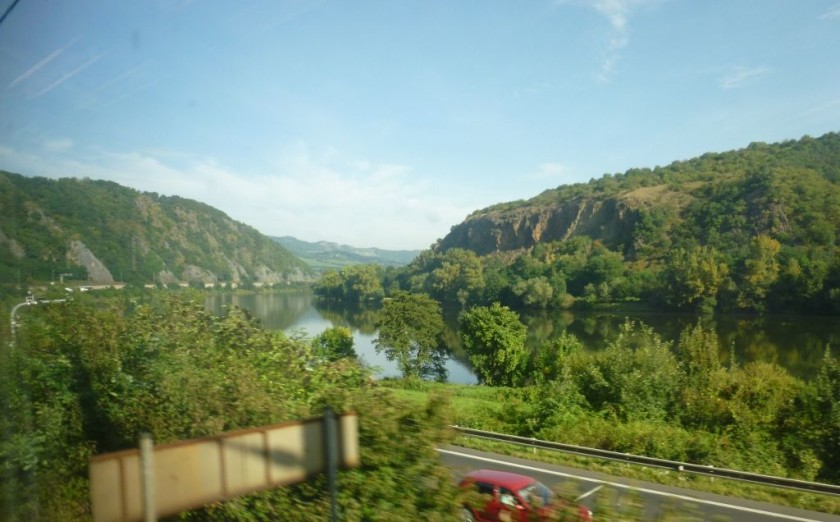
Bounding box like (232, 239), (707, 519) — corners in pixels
(438, 446), (840, 522)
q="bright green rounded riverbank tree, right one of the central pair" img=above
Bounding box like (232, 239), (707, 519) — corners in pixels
(459, 303), (530, 386)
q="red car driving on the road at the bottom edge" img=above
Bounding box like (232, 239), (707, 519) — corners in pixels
(460, 469), (592, 522)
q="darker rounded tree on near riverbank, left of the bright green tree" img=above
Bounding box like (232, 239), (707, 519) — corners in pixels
(373, 292), (446, 381)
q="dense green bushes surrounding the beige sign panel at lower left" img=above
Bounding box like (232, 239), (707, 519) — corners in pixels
(0, 294), (457, 522)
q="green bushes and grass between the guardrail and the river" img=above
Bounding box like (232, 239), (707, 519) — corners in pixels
(391, 316), (840, 484)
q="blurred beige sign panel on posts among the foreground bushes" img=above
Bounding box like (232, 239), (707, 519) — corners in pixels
(90, 409), (359, 522)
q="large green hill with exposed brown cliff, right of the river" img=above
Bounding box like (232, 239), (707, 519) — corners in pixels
(438, 133), (840, 259)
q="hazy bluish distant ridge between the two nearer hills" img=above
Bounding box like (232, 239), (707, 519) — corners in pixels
(272, 236), (420, 270)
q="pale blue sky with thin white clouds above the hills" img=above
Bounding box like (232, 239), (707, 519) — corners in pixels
(0, 0), (840, 249)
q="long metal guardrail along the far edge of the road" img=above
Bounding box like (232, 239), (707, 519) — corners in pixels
(450, 426), (840, 495)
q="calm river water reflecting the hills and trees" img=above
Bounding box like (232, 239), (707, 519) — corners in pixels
(206, 291), (840, 383)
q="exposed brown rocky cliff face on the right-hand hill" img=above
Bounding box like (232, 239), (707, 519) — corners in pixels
(438, 197), (637, 255)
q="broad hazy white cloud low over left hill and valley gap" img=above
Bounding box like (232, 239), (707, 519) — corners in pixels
(0, 144), (472, 249)
